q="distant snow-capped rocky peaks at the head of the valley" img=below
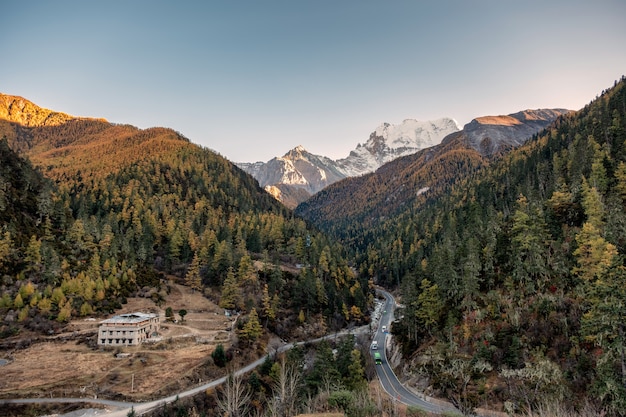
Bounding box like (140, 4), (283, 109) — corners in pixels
(237, 118), (459, 208)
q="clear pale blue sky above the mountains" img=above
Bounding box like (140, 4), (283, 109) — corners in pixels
(0, 0), (626, 162)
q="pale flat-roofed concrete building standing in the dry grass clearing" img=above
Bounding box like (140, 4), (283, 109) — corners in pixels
(98, 313), (159, 346)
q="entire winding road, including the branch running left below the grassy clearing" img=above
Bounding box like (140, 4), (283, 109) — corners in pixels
(0, 289), (456, 417)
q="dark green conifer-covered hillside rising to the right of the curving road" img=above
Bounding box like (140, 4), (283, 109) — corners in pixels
(370, 79), (626, 415)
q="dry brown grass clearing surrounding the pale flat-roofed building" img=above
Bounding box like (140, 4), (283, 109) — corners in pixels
(0, 285), (238, 400)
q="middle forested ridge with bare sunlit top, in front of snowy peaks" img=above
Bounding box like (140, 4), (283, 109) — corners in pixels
(296, 109), (570, 286)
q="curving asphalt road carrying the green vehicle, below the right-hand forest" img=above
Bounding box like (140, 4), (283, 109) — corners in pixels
(370, 289), (458, 414)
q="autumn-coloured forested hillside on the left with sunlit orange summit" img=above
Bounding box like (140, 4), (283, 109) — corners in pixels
(0, 96), (371, 337)
